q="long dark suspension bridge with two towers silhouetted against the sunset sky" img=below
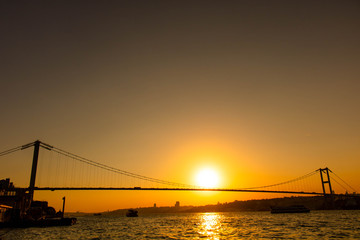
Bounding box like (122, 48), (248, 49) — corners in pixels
(0, 140), (356, 200)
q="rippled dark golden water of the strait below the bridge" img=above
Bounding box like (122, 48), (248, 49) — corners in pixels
(0, 211), (360, 239)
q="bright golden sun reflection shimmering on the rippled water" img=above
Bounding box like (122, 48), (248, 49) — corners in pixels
(199, 213), (221, 239)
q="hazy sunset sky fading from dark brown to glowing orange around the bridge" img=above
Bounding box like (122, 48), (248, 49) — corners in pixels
(0, 0), (360, 211)
